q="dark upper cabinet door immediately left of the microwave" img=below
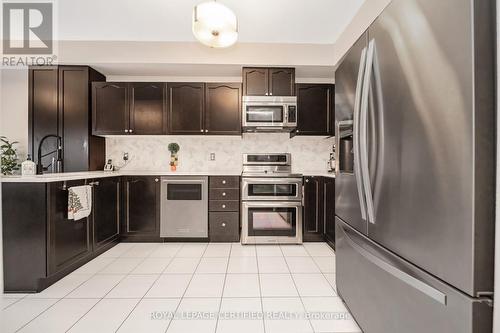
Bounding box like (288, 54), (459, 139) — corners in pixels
(205, 83), (241, 135)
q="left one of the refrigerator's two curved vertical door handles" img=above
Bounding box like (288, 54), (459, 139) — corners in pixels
(354, 47), (366, 221)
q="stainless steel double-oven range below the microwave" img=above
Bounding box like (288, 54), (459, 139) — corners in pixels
(241, 152), (302, 244)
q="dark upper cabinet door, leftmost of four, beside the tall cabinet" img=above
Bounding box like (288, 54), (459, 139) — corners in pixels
(92, 82), (129, 135)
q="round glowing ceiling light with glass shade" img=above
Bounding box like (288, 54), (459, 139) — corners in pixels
(193, 1), (238, 47)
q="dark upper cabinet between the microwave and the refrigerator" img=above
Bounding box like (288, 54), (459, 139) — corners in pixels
(296, 83), (335, 135)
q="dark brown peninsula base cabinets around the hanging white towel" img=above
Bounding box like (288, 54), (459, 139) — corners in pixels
(2, 178), (119, 293)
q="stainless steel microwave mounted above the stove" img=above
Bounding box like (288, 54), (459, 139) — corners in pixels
(242, 96), (297, 132)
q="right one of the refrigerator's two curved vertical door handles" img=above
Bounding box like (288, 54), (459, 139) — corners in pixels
(359, 39), (375, 224)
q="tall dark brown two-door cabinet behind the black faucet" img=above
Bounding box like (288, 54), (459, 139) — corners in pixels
(28, 66), (105, 172)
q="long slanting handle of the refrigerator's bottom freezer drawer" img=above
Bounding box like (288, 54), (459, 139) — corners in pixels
(342, 222), (446, 305)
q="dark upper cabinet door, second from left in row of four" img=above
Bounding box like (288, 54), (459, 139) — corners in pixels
(130, 82), (167, 135)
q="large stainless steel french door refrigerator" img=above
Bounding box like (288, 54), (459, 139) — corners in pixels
(335, 0), (496, 333)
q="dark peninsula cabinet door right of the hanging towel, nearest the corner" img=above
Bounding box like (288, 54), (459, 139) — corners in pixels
(91, 177), (120, 250)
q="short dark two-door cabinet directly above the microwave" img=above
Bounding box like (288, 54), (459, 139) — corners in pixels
(243, 67), (295, 96)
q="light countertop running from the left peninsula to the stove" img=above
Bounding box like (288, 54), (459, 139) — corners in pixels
(0, 170), (241, 183)
